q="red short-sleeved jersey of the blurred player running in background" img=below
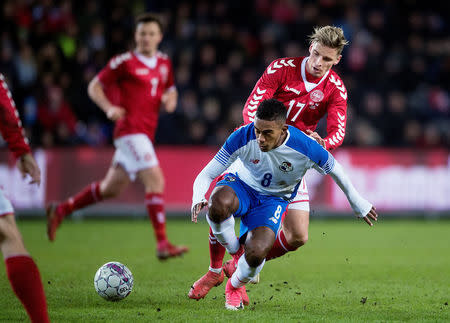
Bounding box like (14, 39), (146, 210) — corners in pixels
(98, 52), (175, 141)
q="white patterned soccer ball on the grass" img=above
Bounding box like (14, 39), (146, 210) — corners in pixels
(94, 261), (134, 301)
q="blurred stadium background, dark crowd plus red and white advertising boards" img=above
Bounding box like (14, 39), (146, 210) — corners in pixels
(0, 0), (450, 217)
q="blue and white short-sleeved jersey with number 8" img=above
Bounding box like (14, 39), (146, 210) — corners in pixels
(214, 123), (334, 200)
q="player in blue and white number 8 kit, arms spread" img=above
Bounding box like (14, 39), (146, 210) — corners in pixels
(191, 99), (378, 310)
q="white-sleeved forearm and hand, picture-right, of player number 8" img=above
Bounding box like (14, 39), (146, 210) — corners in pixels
(329, 159), (378, 226)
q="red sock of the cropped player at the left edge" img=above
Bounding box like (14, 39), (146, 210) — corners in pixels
(5, 255), (50, 323)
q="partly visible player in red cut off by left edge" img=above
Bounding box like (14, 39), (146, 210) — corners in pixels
(0, 73), (50, 322)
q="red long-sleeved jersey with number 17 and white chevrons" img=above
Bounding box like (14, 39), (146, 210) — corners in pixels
(242, 57), (347, 150)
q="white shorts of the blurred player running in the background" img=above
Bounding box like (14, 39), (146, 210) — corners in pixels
(113, 133), (159, 181)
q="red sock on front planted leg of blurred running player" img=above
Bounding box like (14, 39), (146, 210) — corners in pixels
(145, 193), (167, 245)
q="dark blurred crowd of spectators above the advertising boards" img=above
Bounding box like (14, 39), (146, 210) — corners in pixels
(0, 0), (450, 148)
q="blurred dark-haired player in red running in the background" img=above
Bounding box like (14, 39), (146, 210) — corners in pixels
(47, 14), (188, 259)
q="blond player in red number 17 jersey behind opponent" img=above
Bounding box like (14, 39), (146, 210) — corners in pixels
(188, 26), (348, 299)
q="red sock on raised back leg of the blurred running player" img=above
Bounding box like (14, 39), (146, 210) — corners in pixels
(56, 182), (103, 217)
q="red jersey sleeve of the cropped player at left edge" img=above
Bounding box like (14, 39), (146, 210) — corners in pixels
(0, 73), (30, 158)
